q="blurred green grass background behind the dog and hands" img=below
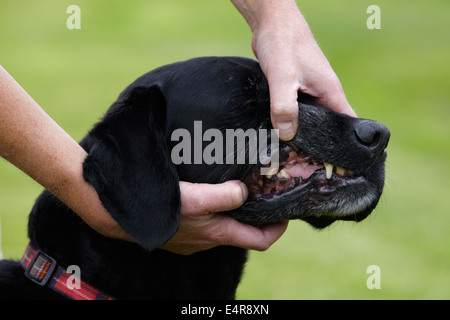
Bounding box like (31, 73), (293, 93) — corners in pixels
(0, 0), (450, 299)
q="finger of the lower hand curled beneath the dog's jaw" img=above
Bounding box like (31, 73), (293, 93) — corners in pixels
(223, 219), (288, 251)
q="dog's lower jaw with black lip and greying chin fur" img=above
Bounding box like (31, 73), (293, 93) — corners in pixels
(229, 169), (382, 229)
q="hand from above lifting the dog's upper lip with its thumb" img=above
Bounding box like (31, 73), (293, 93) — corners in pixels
(233, 0), (356, 140)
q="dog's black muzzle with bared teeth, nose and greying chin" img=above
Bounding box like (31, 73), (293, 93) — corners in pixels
(234, 96), (390, 228)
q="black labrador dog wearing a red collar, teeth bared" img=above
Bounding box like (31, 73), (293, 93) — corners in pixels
(0, 57), (390, 299)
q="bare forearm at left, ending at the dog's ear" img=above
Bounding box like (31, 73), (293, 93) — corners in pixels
(0, 67), (129, 239)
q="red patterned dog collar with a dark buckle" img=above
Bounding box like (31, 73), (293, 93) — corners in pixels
(20, 244), (114, 300)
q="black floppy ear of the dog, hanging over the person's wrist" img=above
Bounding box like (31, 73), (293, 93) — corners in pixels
(82, 85), (181, 250)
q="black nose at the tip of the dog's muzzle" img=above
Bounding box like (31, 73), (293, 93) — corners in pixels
(354, 119), (391, 158)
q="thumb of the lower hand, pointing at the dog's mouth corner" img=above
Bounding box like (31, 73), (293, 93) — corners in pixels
(180, 180), (248, 214)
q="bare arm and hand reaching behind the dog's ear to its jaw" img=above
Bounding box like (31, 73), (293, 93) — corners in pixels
(0, 66), (287, 254)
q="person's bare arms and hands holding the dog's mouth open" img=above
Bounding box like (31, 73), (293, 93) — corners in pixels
(0, 0), (356, 254)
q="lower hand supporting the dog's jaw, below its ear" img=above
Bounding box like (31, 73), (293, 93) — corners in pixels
(161, 180), (288, 255)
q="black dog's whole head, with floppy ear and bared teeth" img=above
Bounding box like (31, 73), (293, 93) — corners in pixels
(82, 57), (390, 249)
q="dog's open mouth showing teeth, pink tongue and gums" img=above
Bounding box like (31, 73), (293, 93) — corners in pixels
(244, 144), (356, 203)
